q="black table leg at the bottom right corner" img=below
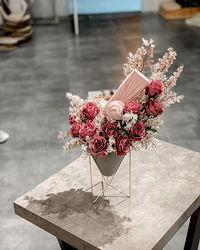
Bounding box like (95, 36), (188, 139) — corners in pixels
(184, 207), (200, 250)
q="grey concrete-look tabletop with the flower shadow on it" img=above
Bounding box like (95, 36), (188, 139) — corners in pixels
(14, 142), (200, 250)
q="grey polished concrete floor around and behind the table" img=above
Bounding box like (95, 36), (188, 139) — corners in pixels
(0, 15), (200, 250)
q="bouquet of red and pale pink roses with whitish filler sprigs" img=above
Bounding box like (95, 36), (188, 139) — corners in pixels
(59, 39), (183, 157)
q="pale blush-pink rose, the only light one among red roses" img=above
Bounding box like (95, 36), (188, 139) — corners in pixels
(105, 101), (124, 120)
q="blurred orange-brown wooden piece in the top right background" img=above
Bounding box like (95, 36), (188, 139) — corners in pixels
(159, 2), (200, 20)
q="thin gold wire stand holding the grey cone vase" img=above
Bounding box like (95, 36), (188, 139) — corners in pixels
(85, 151), (132, 204)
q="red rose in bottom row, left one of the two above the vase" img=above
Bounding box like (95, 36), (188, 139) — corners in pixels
(89, 135), (107, 157)
